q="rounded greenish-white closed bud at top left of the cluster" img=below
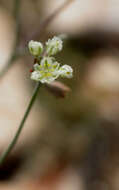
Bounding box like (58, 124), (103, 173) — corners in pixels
(28, 40), (43, 56)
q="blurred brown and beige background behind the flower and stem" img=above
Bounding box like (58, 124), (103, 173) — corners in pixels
(0, 0), (119, 190)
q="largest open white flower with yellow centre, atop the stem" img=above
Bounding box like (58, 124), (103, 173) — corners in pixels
(31, 57), (60, 83)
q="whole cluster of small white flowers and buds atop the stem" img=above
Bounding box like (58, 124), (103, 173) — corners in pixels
(28, 37), (73, 83)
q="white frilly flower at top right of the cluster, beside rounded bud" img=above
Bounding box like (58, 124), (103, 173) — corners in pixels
(46, 36), (63, 56)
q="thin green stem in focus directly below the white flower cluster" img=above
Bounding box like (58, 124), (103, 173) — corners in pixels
(0, 82), (41, 165)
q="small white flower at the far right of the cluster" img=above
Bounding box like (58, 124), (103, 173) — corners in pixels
(59, 65), (73, 78)
